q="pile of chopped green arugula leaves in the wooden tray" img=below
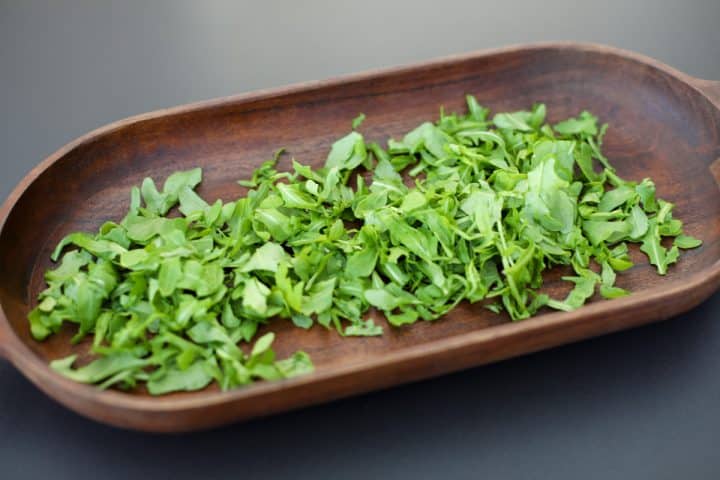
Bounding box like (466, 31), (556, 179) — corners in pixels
(29, 96), (701, 394)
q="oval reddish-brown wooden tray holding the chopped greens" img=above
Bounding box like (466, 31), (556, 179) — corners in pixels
(0, 44), (720, 431)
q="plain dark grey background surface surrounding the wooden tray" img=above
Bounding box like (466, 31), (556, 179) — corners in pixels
(0, 0), (720, 480)
